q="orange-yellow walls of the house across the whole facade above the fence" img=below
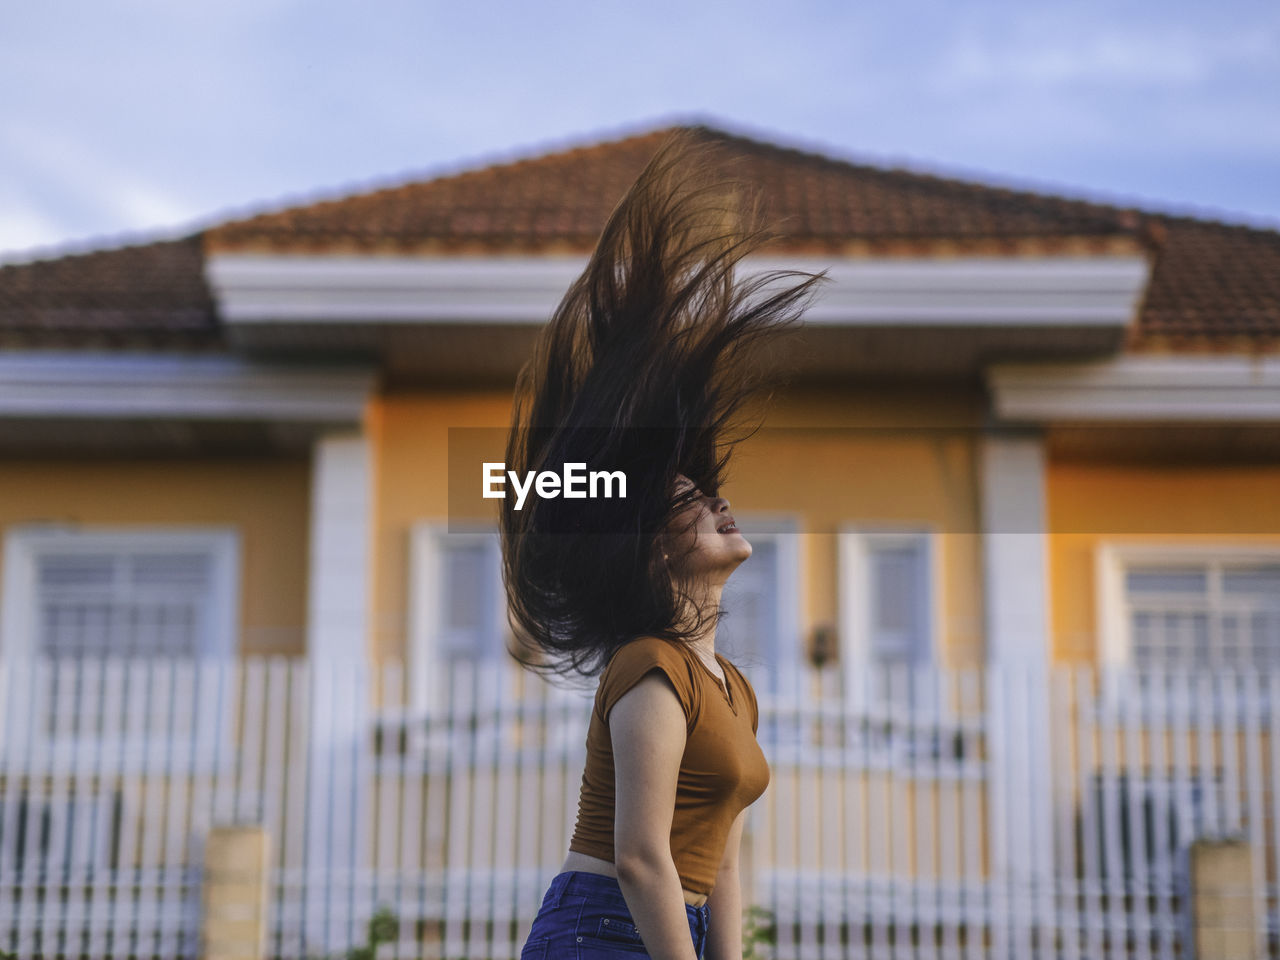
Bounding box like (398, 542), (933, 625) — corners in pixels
(22, 407), (1280, 663)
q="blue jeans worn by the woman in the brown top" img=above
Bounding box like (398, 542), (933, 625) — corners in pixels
(520, 870), (710, 960)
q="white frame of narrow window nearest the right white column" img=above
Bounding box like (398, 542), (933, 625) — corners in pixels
(836, 525), (945, 709)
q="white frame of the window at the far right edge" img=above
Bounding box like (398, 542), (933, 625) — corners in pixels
(1094, 540), (1280, 708)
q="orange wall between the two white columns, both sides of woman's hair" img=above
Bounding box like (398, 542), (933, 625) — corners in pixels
(369, 387), (982, 662)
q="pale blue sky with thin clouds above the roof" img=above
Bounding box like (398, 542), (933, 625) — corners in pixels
(0, 0), (1280, 261)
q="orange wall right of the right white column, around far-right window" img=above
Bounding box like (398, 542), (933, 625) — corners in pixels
(1046, 462), (1280, 660)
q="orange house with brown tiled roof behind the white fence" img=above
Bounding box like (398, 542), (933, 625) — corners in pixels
(0, 128), (1280, 960)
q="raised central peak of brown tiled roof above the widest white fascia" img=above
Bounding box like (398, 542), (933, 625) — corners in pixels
(207, 128), (1137, 252)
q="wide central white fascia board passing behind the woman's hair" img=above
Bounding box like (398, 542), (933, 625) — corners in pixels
(206, 253), (1149, 326)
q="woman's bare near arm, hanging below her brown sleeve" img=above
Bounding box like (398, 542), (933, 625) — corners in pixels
(608, 671), (698, 960)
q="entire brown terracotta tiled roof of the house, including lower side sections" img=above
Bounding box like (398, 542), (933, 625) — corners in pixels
(0, 122), (1280, 351)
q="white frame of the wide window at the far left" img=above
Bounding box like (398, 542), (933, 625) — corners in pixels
(0, 525), (241, 769)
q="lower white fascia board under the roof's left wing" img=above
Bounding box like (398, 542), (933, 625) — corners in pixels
(0, 352), (378, 424)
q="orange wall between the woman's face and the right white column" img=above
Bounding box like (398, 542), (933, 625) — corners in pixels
(723, 387), (983, 664)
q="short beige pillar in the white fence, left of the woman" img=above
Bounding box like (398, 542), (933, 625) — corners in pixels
(201, 826), (270, 960)
